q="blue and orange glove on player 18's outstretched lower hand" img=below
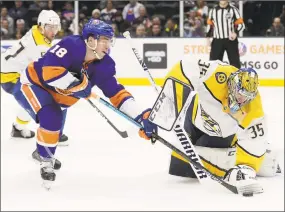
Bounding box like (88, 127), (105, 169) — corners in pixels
(135, 108), (157, 140)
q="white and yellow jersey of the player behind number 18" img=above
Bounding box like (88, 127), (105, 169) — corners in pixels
(1, 25), (52, 83)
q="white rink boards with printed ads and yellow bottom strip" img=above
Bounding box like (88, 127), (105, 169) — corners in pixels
(1, 38), (284, 86)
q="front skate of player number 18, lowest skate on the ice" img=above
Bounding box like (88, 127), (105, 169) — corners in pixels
(40, 157), (56, 190)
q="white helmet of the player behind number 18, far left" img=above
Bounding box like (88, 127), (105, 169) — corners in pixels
(38, 10), (61, 32)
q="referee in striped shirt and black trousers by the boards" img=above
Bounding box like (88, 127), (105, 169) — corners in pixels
(207, 1), (245, 68)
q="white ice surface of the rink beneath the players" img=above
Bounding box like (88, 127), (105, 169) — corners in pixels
(1, 87), (284, 211)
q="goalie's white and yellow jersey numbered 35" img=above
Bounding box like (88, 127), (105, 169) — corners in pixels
(163, 57), (267, 171)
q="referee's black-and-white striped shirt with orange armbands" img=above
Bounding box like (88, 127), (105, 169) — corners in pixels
(207, 4), (245, 39)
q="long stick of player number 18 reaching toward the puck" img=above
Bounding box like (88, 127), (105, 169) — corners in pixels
(89, 95), (241, 194)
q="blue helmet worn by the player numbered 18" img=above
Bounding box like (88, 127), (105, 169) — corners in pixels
(82, 18), (114, 40)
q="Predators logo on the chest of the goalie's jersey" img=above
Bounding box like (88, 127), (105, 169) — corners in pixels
(200, 105), (222, 137)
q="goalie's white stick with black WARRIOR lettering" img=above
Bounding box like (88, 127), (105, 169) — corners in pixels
(123, 31), (208, 183)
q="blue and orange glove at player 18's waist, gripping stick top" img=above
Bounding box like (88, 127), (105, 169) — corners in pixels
(56, 74), (92, 98)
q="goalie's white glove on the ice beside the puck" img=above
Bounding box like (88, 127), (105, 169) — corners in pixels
(224, 165), (263, 194)
